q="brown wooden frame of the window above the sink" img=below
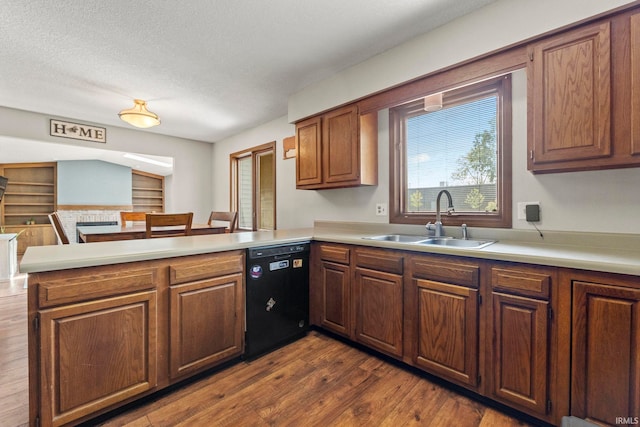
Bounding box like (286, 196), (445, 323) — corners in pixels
(389, 74), (513, 228)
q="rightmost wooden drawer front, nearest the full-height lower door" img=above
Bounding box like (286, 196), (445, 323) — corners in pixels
(491, 267), (551, 299)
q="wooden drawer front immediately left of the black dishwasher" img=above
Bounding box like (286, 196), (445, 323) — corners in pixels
(169, 252), (244, 285)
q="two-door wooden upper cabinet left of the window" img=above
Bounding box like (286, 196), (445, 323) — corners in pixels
(296, 105), (378, 190)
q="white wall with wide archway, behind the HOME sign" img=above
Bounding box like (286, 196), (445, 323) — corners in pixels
(0, 107), (213, 222)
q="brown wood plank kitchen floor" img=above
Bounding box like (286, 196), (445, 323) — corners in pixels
(0, 281), (527, 427)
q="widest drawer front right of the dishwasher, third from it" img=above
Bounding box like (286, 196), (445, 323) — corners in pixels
(411, 257), (480, 288)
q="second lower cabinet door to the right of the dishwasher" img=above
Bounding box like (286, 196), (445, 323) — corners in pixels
(355, 268), (402, 357)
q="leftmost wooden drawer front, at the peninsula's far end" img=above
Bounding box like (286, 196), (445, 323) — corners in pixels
(38, 268), (158, 308)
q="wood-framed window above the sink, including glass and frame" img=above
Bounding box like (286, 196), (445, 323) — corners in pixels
(389, 74), (512, 231)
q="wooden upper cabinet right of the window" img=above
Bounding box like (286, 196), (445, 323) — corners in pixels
(527, 8), (640, 173)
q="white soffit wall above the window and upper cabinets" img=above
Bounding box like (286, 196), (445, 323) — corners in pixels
(288, 0), (632, 123)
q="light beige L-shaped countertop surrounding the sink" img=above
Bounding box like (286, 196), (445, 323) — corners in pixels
(20, 221), (640, 276)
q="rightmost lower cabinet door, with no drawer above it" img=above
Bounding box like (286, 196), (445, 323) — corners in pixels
(571, 282), (640, 425)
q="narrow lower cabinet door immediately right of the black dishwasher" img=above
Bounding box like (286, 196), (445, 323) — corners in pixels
(320, 261), (351, 337)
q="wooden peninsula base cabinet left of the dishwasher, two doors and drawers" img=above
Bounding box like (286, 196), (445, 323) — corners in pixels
(28, 251), (244, 427)
